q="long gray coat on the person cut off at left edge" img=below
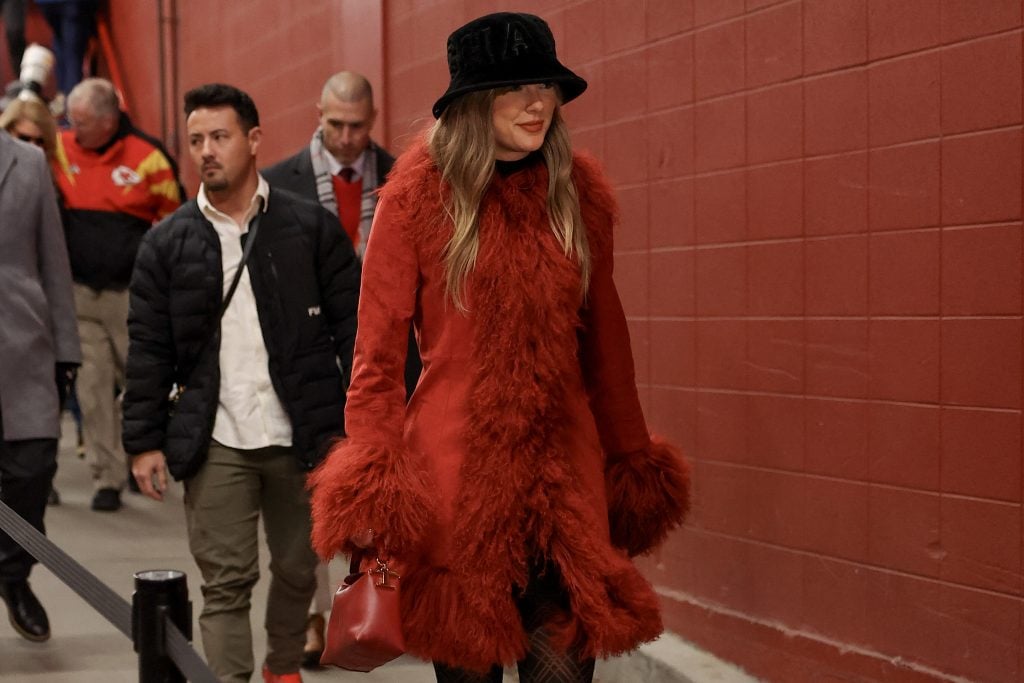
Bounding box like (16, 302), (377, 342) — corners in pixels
(0, 131), (82, 441)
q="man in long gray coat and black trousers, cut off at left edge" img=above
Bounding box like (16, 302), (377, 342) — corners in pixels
(0, 126), (82, 641)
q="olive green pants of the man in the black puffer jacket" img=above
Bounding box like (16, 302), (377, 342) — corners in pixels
(185, 442), (316, 683)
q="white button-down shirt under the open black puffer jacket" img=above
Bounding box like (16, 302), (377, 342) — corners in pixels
(196, 176), (292, 450)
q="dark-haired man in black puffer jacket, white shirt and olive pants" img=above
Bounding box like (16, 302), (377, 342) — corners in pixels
(124, 84), (359, 681)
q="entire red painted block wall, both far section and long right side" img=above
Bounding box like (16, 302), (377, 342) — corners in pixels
(92, 0), (1024, 682)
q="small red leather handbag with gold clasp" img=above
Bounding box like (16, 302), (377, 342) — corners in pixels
(321, 553), (406, 672)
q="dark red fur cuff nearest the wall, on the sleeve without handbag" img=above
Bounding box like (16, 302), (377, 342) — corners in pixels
(604, 439), (690, 556)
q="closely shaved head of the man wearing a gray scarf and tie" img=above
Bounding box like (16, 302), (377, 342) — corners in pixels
(316, 71), (377, 166)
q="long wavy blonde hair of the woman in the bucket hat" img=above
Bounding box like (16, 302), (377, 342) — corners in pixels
(427, 89), (591, 312)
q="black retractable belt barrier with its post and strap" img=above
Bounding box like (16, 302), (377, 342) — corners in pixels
(0, 501), (219, 683)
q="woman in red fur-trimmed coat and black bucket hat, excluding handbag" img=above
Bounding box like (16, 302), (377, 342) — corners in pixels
(310, 13), (688, 683)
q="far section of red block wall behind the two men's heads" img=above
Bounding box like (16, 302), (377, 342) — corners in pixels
(109, 0), (387, 189)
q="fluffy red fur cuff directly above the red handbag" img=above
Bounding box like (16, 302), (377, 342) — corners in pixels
(307, 439), (433, 560)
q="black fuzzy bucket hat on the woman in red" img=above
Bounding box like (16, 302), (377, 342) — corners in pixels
(433, 12), (587, 119)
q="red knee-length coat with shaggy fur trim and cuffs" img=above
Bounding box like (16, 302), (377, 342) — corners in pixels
(310, 142), (688, 670)
